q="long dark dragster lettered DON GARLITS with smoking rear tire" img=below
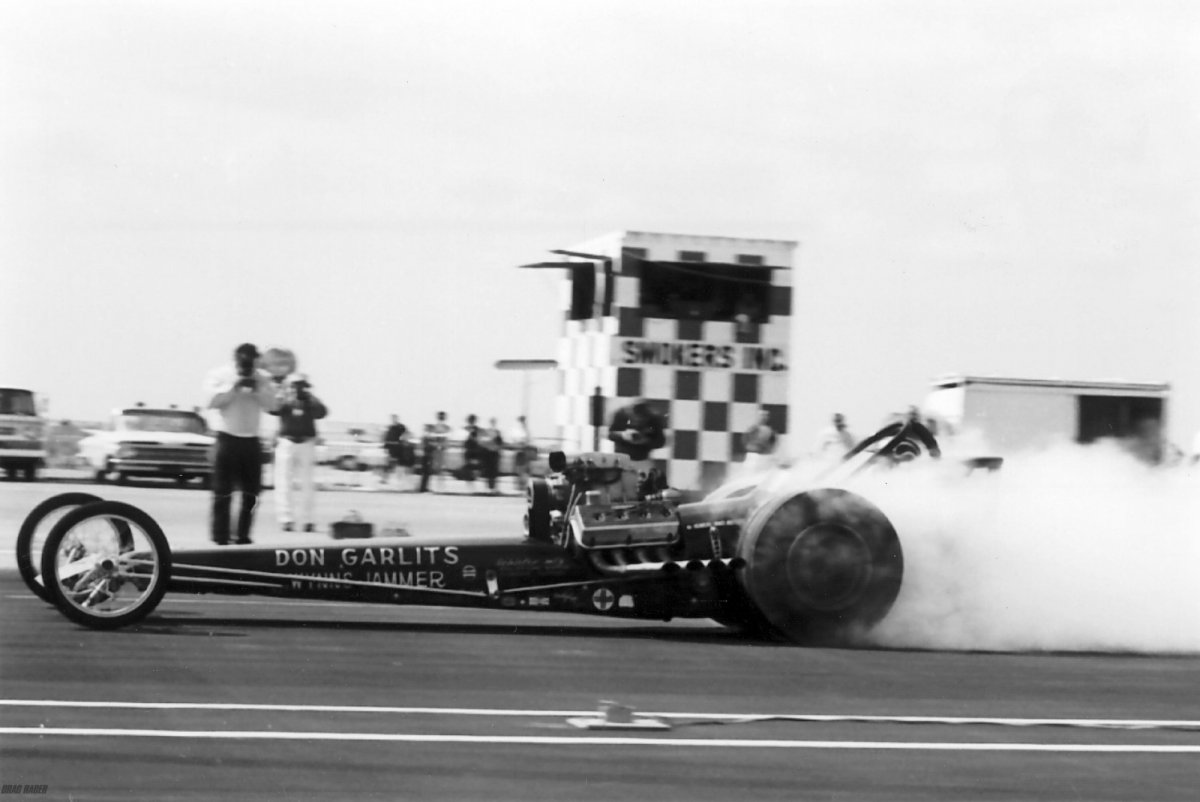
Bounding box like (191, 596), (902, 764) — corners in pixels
(17, 423), (937, 644)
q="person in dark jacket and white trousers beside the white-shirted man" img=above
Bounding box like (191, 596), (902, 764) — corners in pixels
(271, 373), (329, 532)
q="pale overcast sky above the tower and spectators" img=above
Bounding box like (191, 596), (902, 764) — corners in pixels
(0, 0), (1200, 445)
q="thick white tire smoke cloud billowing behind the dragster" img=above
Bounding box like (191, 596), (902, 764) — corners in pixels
(830, 444), (1200, 653)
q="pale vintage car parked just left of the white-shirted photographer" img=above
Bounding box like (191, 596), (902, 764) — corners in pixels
(79, 405), (215, 485)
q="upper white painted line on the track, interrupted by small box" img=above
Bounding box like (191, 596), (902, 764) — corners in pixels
(0, 699), (1200, 730)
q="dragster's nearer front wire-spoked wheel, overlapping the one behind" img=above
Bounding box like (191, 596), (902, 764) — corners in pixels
(42, 501), (172, 629)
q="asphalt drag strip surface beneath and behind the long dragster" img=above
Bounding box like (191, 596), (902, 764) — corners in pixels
(0, 481), (1200, 801)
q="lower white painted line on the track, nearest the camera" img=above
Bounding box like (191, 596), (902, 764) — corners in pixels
(0, 726), (1200, 754)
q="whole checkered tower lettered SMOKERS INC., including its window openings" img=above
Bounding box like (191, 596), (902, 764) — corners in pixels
(524, 231), (797, 489)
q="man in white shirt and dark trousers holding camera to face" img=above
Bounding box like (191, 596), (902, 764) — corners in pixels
(204, 342), (277, 546)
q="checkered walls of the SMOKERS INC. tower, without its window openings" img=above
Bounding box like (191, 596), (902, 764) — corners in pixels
(557, 232), (794, 489)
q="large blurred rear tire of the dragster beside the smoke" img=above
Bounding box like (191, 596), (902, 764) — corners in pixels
(738, 489), (904, 646)
